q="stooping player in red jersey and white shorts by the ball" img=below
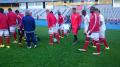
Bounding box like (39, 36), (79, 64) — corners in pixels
(46, 9), (60, 45)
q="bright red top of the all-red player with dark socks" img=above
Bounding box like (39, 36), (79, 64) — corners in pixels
(71, 13), (81, 28)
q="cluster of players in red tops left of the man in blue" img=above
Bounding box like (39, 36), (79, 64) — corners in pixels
(0, 8), (24, 48)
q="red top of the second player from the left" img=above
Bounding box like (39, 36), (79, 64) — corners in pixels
(7, 11), (17, 26)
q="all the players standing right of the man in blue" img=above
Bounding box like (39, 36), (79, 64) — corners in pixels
(46, 6), (109, 55)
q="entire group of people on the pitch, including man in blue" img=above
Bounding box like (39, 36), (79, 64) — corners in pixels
(0, 7), (109, 55)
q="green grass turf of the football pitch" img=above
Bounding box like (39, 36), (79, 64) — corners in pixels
(0, 27), (120, 67)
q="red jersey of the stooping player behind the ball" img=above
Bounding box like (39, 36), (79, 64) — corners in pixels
(47, 13), (57, 28)
